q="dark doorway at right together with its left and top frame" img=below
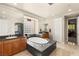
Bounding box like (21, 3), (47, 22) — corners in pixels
(64, 17), (77, 44)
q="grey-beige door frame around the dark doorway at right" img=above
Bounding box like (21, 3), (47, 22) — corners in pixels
(64, 16), (78, 44)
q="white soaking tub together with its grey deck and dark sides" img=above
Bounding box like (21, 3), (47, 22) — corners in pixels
(27, 37), (56, 56)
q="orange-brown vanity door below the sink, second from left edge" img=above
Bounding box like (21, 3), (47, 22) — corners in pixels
(3, 40), (12, 56)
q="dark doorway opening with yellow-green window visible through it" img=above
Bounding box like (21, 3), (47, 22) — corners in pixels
(68, 19), (77, 44)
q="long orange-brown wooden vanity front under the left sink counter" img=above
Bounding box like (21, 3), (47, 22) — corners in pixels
(3, 37), (26, 56)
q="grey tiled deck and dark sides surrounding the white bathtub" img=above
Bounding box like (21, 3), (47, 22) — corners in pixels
(27, 37), (56, 56)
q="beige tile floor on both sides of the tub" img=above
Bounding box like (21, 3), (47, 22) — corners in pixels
(14, 43), (79, 56)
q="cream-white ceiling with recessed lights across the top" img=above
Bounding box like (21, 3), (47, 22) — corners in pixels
(0, 3), (79, 18)
